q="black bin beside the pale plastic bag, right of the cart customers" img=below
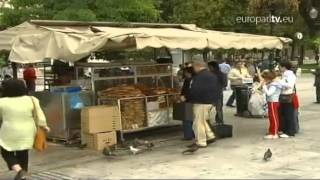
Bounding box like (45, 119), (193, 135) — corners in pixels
(235, 86), (250, 116)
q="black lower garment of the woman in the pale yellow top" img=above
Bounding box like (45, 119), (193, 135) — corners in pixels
(0, 147), (29, 171)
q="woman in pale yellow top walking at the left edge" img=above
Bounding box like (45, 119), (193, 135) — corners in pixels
(0, 79), (49, 180)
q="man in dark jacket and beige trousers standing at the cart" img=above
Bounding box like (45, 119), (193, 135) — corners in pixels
(185, 61), (221, 152)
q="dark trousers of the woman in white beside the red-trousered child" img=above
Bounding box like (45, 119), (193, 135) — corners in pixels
(280, 103), (297, 136)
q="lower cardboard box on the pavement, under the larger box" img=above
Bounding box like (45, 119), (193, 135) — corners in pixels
(82, 131), (117, 151)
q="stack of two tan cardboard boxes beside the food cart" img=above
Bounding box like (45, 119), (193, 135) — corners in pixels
(81, 106), (121, 151)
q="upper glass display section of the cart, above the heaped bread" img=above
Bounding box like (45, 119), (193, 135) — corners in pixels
(75, 63), (173, 93)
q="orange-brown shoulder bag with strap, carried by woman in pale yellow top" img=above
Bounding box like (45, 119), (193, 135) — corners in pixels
(31, 97), (48, 152)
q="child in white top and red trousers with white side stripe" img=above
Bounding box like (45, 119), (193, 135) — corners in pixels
(261, 71), (281, 139)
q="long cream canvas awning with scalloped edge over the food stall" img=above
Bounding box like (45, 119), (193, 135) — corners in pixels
(0, 22), (291, 63)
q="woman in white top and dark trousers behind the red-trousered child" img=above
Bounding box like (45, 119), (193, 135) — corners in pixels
(279, 61), (297, 138)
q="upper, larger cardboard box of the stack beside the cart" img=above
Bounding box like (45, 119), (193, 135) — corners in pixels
(81, 106), (121, 134)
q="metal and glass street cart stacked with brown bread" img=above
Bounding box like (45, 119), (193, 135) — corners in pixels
(75, 62), (179, 139)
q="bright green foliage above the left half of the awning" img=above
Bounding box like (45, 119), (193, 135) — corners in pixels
(0, 0), (160, 26)
